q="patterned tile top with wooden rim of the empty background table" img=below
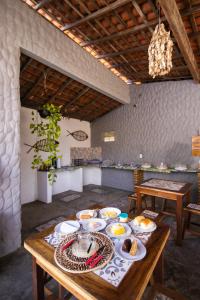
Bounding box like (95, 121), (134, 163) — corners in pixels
(135, 178), (192, 195)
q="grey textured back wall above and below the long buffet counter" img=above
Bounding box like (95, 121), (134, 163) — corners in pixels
(92, 80), (200, 190)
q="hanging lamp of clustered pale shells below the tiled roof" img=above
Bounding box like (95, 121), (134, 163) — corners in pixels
(148, 6), (173, 78)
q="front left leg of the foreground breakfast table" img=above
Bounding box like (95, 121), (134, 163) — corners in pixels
(32, 257), (44, 300)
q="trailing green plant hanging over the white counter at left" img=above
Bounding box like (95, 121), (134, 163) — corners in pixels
(30, 103), (62, 184)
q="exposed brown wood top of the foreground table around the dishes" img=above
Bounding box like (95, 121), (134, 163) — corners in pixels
(24, 206), (170, 300)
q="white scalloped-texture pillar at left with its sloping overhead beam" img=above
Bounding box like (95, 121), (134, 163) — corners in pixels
(0, 0), (130, 256)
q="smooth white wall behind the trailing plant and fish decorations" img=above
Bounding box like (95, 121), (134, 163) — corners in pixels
(20, 107), (91, 204)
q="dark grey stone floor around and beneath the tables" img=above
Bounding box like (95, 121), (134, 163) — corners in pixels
(0, 186), (200, 300)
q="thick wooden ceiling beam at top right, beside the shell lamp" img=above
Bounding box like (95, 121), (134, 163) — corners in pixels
(159, 0), (200, 82)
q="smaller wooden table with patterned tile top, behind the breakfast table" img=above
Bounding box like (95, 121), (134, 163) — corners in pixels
(136, 179), (192, 245)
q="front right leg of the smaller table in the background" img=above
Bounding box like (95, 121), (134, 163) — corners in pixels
(176, 196), (183, 246)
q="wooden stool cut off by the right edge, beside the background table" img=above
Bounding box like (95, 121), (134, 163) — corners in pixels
(183, 203), (200, 238)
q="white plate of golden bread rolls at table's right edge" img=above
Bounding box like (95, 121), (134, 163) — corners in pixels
(130, 216), (157, 232)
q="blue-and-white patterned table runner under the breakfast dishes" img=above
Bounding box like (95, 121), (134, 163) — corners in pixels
(44, 220), (151, 287)
